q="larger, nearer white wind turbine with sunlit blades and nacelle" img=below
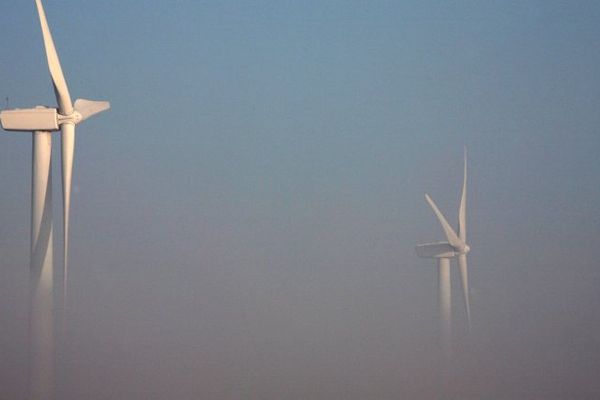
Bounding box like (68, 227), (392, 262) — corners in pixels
(0, 0), (110, 399)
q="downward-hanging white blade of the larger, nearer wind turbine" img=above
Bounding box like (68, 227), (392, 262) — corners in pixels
(61, 123), (75, 306)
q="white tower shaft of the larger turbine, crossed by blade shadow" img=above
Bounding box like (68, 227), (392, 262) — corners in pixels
(29, 131), (54, 400)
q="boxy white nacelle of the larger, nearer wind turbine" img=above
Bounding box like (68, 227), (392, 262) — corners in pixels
(0, 107), (59, 131)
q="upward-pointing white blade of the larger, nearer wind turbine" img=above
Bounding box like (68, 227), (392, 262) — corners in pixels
(35, 0), (73, 115)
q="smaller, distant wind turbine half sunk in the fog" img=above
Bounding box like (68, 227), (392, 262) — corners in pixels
(416, 148), (471, 354)
